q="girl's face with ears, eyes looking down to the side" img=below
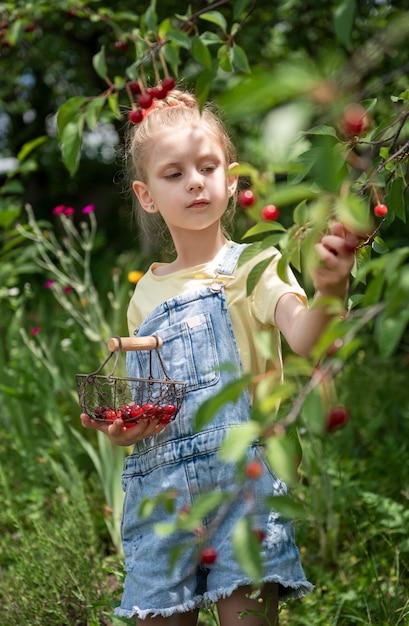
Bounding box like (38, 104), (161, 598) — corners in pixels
(133, 125), (237, 237)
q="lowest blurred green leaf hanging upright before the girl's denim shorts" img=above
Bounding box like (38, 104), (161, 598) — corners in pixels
(232, 517), (263, 583)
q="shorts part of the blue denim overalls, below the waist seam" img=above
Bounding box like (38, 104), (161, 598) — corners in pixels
(115, 442), (313, 619)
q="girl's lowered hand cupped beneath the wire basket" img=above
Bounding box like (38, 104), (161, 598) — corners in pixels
(80, 413), (167, 446)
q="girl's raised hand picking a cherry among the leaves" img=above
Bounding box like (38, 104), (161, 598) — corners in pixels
(313, 222), (359, 299)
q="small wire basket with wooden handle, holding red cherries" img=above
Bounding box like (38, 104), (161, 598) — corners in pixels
(76, 335), (186, 426)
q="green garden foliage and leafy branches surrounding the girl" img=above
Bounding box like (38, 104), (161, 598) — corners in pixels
(0, 0), (409, 626)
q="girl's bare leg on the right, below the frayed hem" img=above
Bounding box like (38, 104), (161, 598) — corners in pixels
(217, 583), (278, 626)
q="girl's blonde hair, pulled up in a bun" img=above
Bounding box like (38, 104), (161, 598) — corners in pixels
(125, 89), (236, 249)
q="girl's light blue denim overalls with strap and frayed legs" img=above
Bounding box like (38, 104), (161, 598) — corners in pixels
(115, 244), (312, 619)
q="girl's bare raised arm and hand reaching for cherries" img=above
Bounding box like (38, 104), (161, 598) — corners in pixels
(275, 223), (358, 356)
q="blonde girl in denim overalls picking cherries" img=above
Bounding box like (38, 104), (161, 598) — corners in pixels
(81, 90), (354, 626)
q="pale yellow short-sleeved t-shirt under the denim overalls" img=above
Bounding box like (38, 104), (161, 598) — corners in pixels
(128, 241), (307, 374)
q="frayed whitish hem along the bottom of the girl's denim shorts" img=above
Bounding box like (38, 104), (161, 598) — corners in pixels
(114, 576), (315, 620)
